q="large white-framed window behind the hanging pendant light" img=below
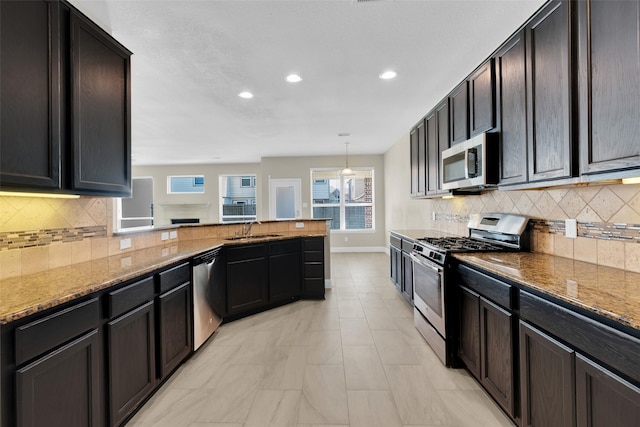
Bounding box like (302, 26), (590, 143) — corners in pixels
(311, 169), (374, 230)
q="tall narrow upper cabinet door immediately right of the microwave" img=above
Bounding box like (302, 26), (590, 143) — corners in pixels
(494, 31), (528, 185)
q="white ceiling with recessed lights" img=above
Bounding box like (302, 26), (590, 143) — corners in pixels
(71, 0), (544, 165)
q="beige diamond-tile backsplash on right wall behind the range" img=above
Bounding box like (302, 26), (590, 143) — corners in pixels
(431, 184), (640, 272)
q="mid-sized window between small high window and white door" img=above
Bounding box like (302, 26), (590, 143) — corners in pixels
(219, 175), (257, 222)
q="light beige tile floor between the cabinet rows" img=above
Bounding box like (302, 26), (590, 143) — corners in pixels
(127, 253), (513, 427)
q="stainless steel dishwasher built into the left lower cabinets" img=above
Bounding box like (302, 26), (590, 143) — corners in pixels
(192, 248), (224, 351)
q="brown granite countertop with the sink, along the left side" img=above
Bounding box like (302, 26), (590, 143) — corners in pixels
(0, 231), (325, 325)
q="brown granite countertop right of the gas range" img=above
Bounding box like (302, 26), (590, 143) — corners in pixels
(454, 252), (640, 331)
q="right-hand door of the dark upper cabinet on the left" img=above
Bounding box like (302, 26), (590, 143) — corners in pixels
(71, 12), (131, 196)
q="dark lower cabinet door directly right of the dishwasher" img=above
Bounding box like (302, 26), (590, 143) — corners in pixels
(227, 254), (269, 314)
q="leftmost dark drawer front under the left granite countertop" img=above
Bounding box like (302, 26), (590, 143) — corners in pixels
(16, 298), (100, 365)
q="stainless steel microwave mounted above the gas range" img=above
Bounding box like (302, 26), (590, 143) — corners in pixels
(441, 133), (500, 190)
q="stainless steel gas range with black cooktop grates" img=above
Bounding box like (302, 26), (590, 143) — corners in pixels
(411, 214), (530, 366)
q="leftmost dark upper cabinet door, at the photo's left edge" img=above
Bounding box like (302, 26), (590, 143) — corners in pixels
(0, 1), (62, 190)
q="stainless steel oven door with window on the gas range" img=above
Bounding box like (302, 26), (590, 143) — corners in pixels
(411, 253), (447, 338)
